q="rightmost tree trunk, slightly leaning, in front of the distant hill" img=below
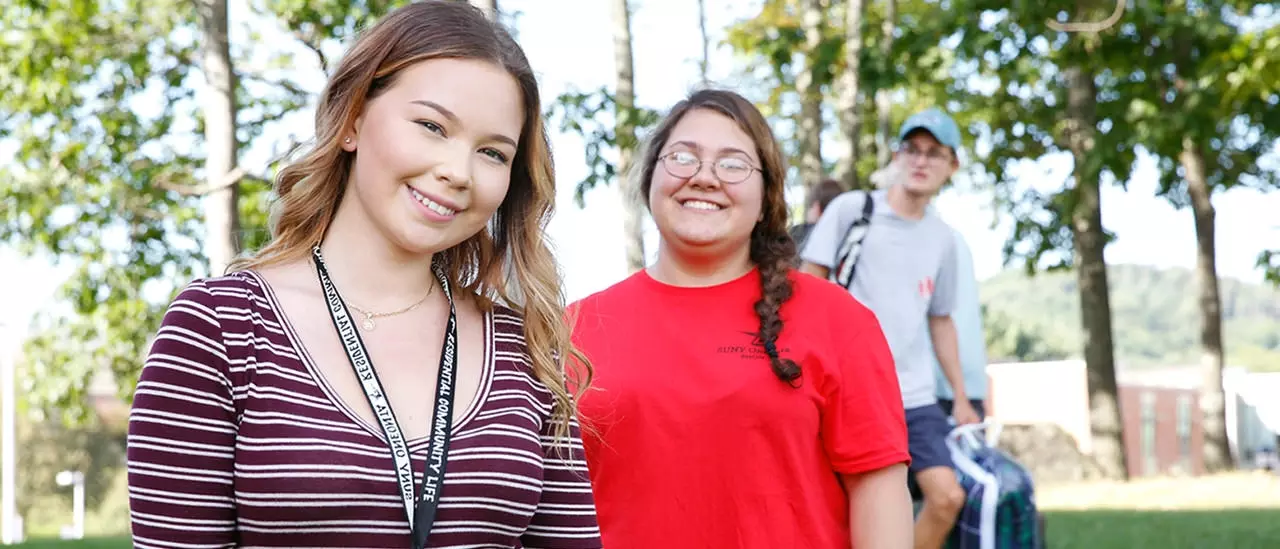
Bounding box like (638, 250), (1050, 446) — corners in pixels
(1179, 138), (1233, 472)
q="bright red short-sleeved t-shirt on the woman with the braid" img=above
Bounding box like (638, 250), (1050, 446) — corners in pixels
(572, 270), (910, 549)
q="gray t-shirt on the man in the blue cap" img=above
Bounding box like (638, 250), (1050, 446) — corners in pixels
(800, 191), (956, 408)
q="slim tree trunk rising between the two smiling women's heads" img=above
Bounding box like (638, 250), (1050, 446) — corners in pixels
(613, 0), (645, 273)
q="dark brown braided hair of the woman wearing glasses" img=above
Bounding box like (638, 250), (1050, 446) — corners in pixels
(636, 90), (801, 386)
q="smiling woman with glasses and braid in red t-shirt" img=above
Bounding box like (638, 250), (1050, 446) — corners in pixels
(571, 90), (911, 549)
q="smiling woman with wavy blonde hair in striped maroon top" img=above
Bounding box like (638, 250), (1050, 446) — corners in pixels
(128, 0), (600, 549)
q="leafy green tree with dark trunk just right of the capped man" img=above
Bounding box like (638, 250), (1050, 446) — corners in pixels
(899, 0), (1134, 479)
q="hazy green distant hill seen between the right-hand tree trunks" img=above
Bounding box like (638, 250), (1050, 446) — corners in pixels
(982, 265), (1280, 371)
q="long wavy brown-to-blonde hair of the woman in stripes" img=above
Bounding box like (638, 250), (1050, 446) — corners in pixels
(230, 0), (591, 438)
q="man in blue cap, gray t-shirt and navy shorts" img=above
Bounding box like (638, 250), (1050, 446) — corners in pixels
(800, 109), (978, 549)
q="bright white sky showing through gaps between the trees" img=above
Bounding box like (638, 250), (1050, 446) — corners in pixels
(0, 0), (1280, 338)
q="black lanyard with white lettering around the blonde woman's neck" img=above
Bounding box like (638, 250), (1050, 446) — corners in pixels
(311, 244), (458, 549)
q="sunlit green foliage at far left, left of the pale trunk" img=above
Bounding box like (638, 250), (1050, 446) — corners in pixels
(0, 0), (202, 418)
